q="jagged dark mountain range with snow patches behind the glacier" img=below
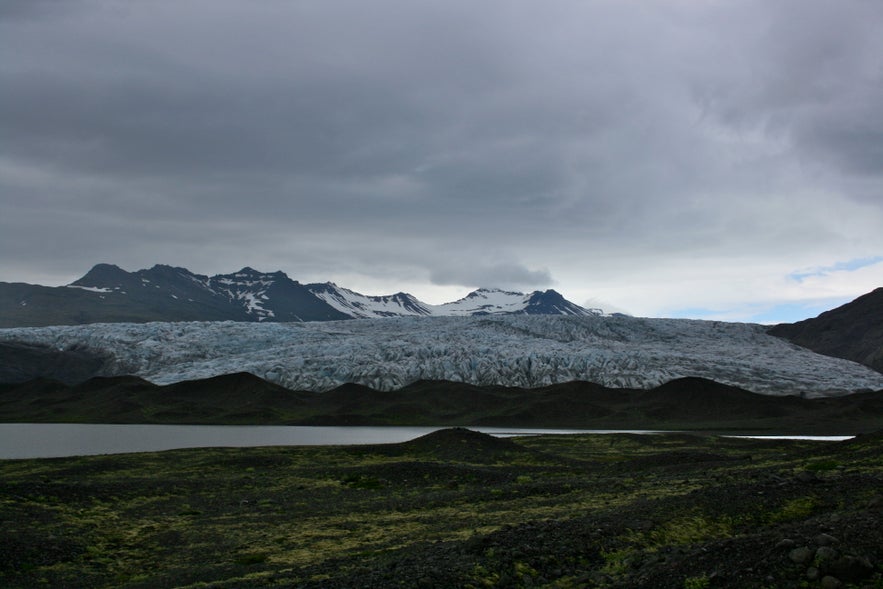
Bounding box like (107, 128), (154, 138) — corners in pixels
(0, 264), (604, 327)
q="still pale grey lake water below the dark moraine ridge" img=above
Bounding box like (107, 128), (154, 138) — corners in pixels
(0, 423), (851, 459)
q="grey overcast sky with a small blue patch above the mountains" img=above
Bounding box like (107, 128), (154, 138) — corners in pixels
(0, 0), (883, 323)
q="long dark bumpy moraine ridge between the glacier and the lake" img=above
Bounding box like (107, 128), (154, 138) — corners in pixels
(0, 373), (883, 434)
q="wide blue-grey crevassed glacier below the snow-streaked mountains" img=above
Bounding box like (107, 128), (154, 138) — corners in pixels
(0, 315), (883, 397)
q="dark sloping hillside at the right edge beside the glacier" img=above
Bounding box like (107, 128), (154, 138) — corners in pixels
(769, 288), (883, 372)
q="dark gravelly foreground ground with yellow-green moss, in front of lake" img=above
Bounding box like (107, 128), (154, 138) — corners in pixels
(0, 430), (883, 588)
